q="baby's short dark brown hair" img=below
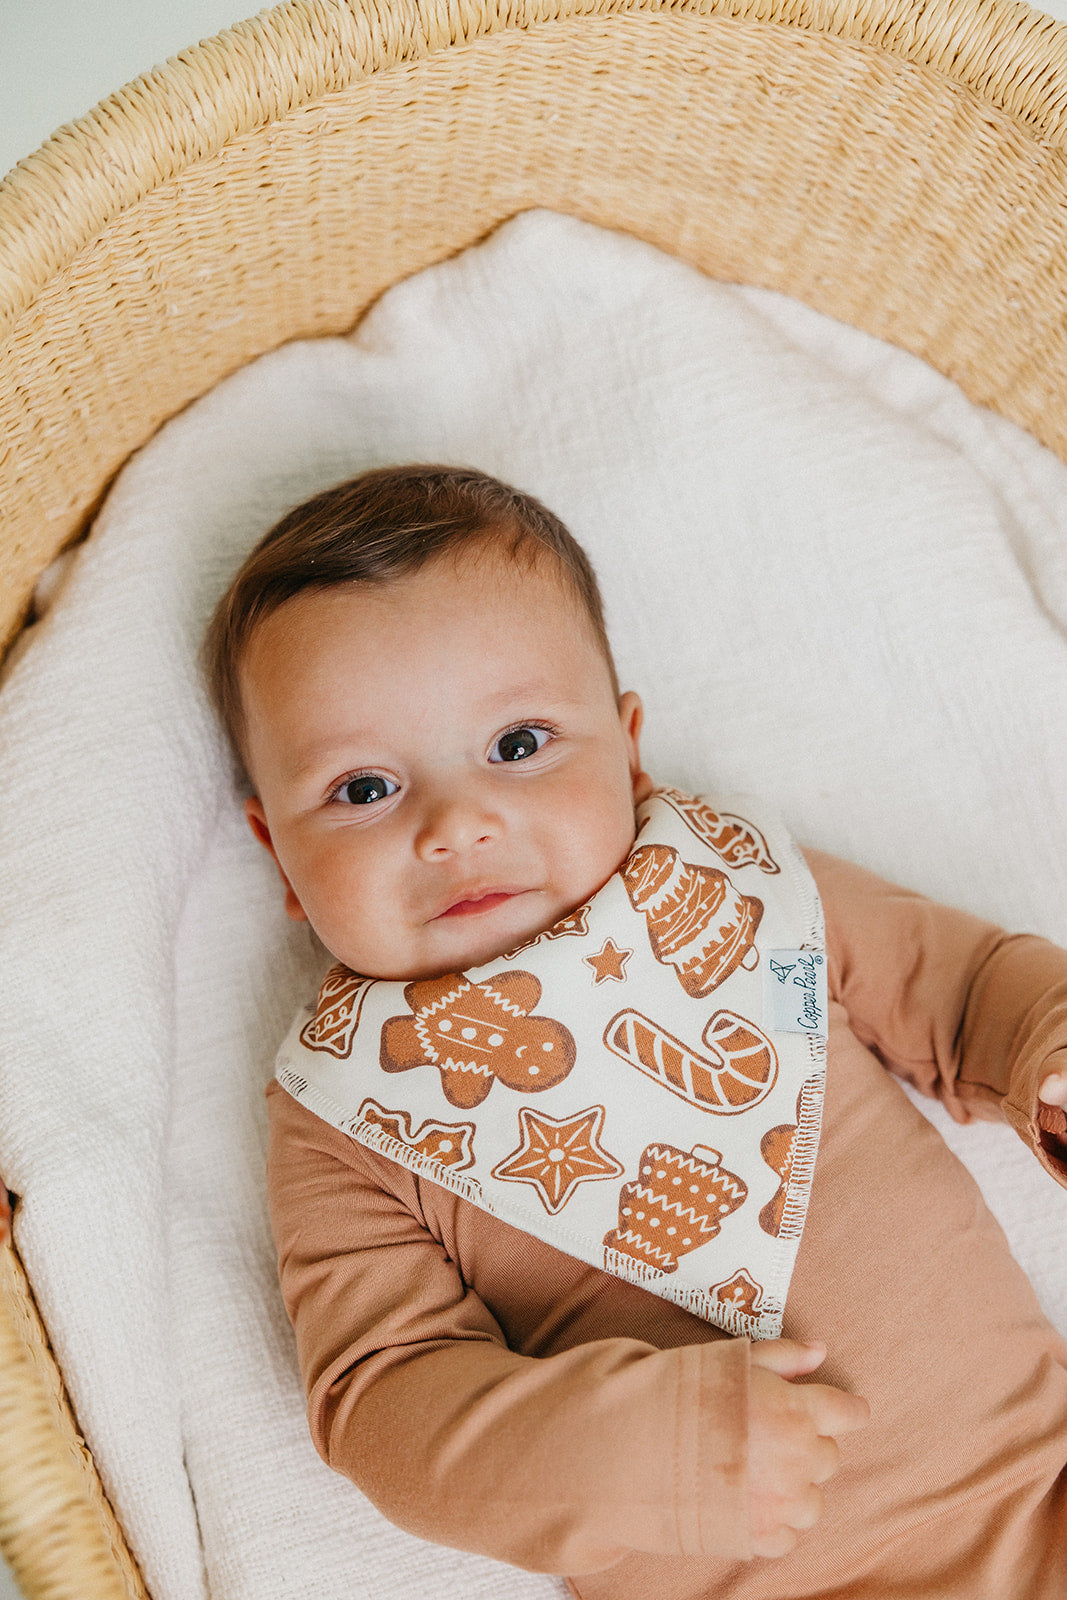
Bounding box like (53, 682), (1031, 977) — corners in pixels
(203, 466), (619, 768)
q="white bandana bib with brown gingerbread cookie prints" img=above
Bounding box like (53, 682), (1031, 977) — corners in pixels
(277, 789), (827, 1339)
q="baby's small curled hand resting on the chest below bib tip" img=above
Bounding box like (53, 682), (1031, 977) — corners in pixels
(749, 1339), (870, 1555)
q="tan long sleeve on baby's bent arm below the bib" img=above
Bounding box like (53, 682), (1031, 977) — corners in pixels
(269, 1085), (749, 1574)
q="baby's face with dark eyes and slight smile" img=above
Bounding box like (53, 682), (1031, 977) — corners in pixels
(242, 554), (651, 979)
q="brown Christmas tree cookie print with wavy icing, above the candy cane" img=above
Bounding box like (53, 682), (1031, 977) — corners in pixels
(622, 845), (763, 1000)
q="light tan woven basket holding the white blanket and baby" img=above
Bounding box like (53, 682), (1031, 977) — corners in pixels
(0, 0), (1067, 1600)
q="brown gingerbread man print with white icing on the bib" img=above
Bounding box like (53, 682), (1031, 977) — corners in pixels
(379, 971), (577, 1110)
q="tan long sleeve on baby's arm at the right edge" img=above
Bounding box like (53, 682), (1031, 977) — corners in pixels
(805, 850), (1067, 1184)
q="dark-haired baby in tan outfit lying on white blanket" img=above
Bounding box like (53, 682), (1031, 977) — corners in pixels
(208, 467), (1067, 1600)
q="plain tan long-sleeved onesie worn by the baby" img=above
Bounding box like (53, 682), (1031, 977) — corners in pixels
(267, 851), (1067, 1600)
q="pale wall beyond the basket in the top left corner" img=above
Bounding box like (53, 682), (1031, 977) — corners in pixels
(0, 0), (1067, 1600)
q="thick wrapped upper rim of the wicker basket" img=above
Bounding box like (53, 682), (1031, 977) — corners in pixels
(0, 0), (1067, 330)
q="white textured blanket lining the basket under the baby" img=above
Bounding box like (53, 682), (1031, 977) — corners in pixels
(0, 213), (1067, 1600)
